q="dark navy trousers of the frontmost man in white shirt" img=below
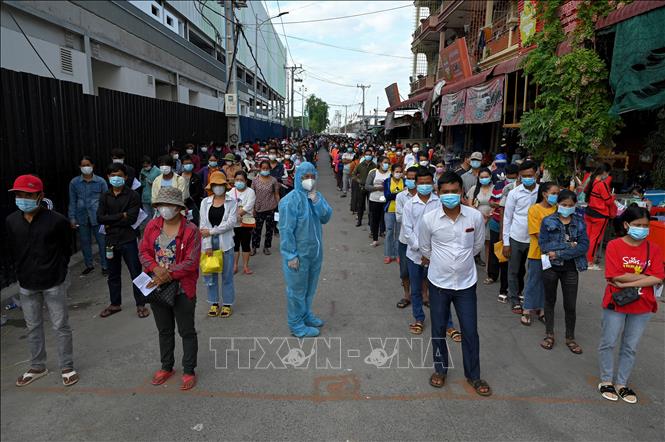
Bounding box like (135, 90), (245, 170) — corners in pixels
(429, 282), (480, 381)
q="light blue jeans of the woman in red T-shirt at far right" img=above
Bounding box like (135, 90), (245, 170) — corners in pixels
(598, 309), (653, 385)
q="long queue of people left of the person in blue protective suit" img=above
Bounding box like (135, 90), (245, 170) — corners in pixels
(6, 139), (330, 390)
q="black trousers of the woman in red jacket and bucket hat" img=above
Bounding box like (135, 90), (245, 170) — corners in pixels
(150, 293), (199, 374)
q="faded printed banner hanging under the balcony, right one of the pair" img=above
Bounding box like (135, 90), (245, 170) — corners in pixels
(464, 76), (504, 124)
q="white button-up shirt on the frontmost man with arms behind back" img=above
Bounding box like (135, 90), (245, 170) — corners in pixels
(418, 206), (485, 290)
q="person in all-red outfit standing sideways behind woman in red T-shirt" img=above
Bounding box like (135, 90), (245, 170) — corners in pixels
(584, 163), (616, 270)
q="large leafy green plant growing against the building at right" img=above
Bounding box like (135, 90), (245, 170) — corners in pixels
(520, 0), (619, 180)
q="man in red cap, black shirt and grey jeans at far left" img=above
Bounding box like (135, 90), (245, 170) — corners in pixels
(6, 175), (79, 387)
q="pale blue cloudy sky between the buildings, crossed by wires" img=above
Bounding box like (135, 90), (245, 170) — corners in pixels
(265, 0), (414, 120)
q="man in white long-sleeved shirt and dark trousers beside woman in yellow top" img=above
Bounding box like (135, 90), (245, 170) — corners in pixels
(503, 161), (538, 315)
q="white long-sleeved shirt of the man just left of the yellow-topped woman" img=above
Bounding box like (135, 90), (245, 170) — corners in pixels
(503, 184), (538, 247)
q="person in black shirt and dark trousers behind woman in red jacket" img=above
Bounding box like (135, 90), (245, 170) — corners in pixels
(97, 163), (150, 318)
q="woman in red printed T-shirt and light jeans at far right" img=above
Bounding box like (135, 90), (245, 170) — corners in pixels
(598, 205), (665, 404)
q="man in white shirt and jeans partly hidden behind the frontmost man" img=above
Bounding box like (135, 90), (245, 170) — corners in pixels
(400, 167), (452, 335)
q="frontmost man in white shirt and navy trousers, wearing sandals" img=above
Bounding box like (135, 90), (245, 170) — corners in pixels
(418, 172), (492, 396)
